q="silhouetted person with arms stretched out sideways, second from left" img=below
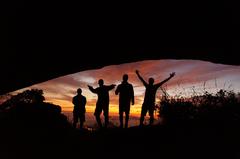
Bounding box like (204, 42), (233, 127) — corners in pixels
(88, 79), (115, 128)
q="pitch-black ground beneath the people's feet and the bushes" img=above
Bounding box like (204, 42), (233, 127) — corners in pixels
(0, 123), (240, 159)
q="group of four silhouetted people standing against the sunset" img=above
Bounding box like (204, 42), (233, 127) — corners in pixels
(72, 70), (175, 129)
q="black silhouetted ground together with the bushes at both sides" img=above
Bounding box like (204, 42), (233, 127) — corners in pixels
(0, 87), (240, 158)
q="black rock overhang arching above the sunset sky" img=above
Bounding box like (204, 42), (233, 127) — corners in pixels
(0, 1), (240, 94)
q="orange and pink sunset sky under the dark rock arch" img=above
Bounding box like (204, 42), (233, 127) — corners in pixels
(10, 60), (240, 118)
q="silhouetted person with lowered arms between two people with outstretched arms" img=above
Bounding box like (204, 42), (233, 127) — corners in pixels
(115, 74), (134, 128)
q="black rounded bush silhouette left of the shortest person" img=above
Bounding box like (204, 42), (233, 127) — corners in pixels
(0, 89), (69, 132)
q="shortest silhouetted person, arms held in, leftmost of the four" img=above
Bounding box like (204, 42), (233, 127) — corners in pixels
(72, 88), (87, 129)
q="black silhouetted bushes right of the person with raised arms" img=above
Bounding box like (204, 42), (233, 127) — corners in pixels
(159, 89), (240, 124)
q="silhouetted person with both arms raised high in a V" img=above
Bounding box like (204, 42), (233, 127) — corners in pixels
(136, 70), (175, 126)
